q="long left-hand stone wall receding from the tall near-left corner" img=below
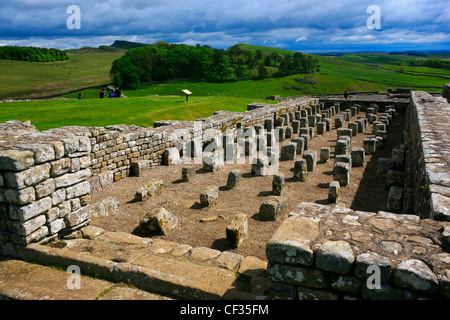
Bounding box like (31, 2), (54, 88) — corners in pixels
(0, 98), (317, 246)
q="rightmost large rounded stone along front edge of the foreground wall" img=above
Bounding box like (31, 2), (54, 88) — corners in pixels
(393, 259), (439, 292)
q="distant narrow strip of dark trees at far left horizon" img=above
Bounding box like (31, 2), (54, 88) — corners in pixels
(0, 46), (69, 62)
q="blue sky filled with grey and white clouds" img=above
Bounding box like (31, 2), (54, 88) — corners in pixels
(0, 0), (450, 52)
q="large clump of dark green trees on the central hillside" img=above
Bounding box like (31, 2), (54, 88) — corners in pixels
(111, 43), (319, 89)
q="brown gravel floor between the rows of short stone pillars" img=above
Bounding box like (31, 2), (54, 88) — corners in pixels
(91, 112), (404, 260)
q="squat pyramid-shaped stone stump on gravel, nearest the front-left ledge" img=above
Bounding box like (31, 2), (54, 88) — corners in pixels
(139, 207), (178, 236)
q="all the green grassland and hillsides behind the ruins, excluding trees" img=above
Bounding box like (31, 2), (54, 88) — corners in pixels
(0, 44), (450, 130)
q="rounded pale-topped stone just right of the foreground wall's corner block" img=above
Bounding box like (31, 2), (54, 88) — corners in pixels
(316, 241), (355, 274)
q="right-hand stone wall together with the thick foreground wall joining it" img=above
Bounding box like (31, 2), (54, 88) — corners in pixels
(266, 92), (450, 300)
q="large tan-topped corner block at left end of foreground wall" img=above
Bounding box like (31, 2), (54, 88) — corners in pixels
(266, 216), (319, 266)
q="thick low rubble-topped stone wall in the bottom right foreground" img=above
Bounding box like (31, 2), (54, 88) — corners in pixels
(266, 203), (450, 300)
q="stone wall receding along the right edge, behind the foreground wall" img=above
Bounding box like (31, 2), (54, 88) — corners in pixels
(406, 92), (450, 221)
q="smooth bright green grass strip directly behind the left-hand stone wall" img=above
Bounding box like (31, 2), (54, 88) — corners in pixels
(0, 97), (274, 131)
